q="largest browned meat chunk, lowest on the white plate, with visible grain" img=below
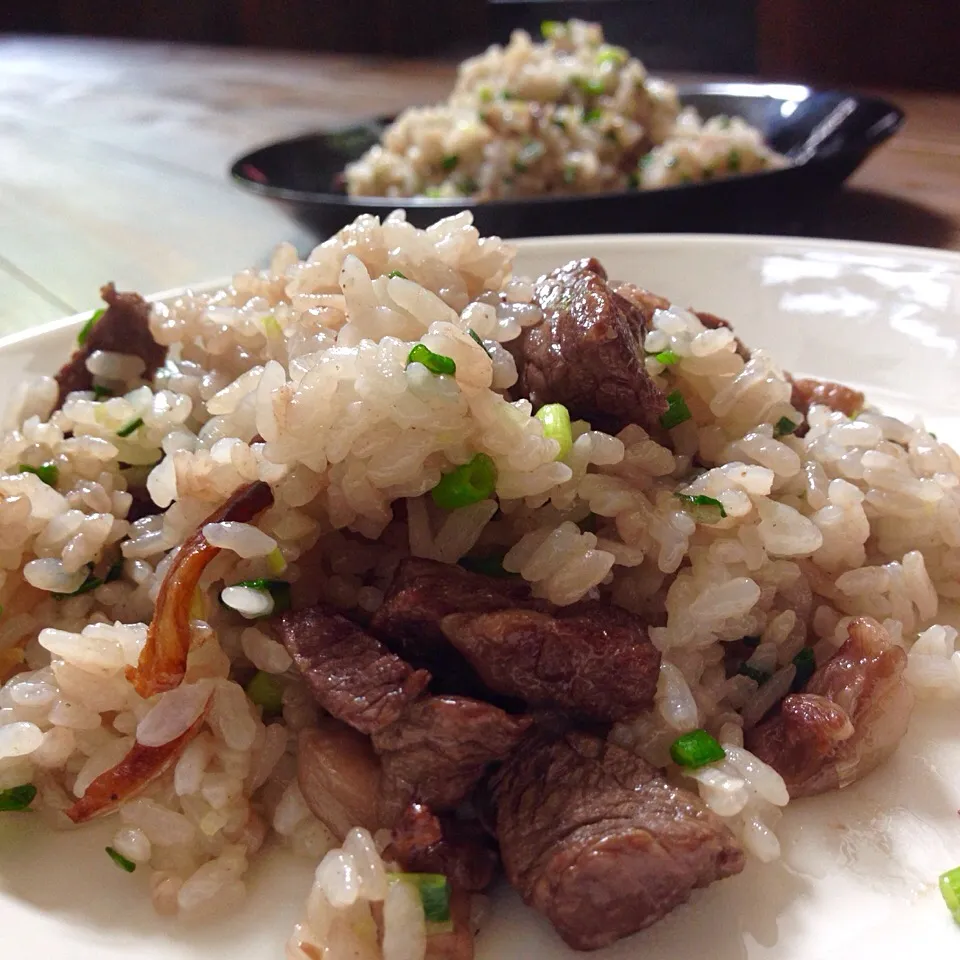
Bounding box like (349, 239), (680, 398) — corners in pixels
(493, 733), (744, 950)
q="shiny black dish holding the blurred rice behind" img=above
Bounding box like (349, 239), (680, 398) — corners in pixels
(230, 83), (903, 237)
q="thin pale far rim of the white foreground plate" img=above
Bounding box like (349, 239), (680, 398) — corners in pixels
(0, 233), (960, 351)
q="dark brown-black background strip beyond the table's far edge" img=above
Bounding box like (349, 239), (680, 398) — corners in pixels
(0, 0), (960, 90)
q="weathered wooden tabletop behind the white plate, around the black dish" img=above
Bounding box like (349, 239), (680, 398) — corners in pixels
(0, 38), (960, 334)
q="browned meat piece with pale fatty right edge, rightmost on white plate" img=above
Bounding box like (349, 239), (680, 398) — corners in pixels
(746, 617), (913, 797)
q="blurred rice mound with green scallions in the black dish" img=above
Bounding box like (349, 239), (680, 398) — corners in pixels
(344, 20), (786, 200)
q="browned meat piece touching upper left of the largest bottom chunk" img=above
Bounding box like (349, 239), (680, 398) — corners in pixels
(373, 697), (531, 823)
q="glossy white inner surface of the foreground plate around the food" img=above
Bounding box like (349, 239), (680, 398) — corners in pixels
(0, 236), (960, 960)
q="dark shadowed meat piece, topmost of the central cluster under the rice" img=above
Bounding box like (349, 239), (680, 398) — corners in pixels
(370, 558), (534, 661)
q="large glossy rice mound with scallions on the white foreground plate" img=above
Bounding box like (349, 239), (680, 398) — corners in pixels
(0, 212), (960, 960)
